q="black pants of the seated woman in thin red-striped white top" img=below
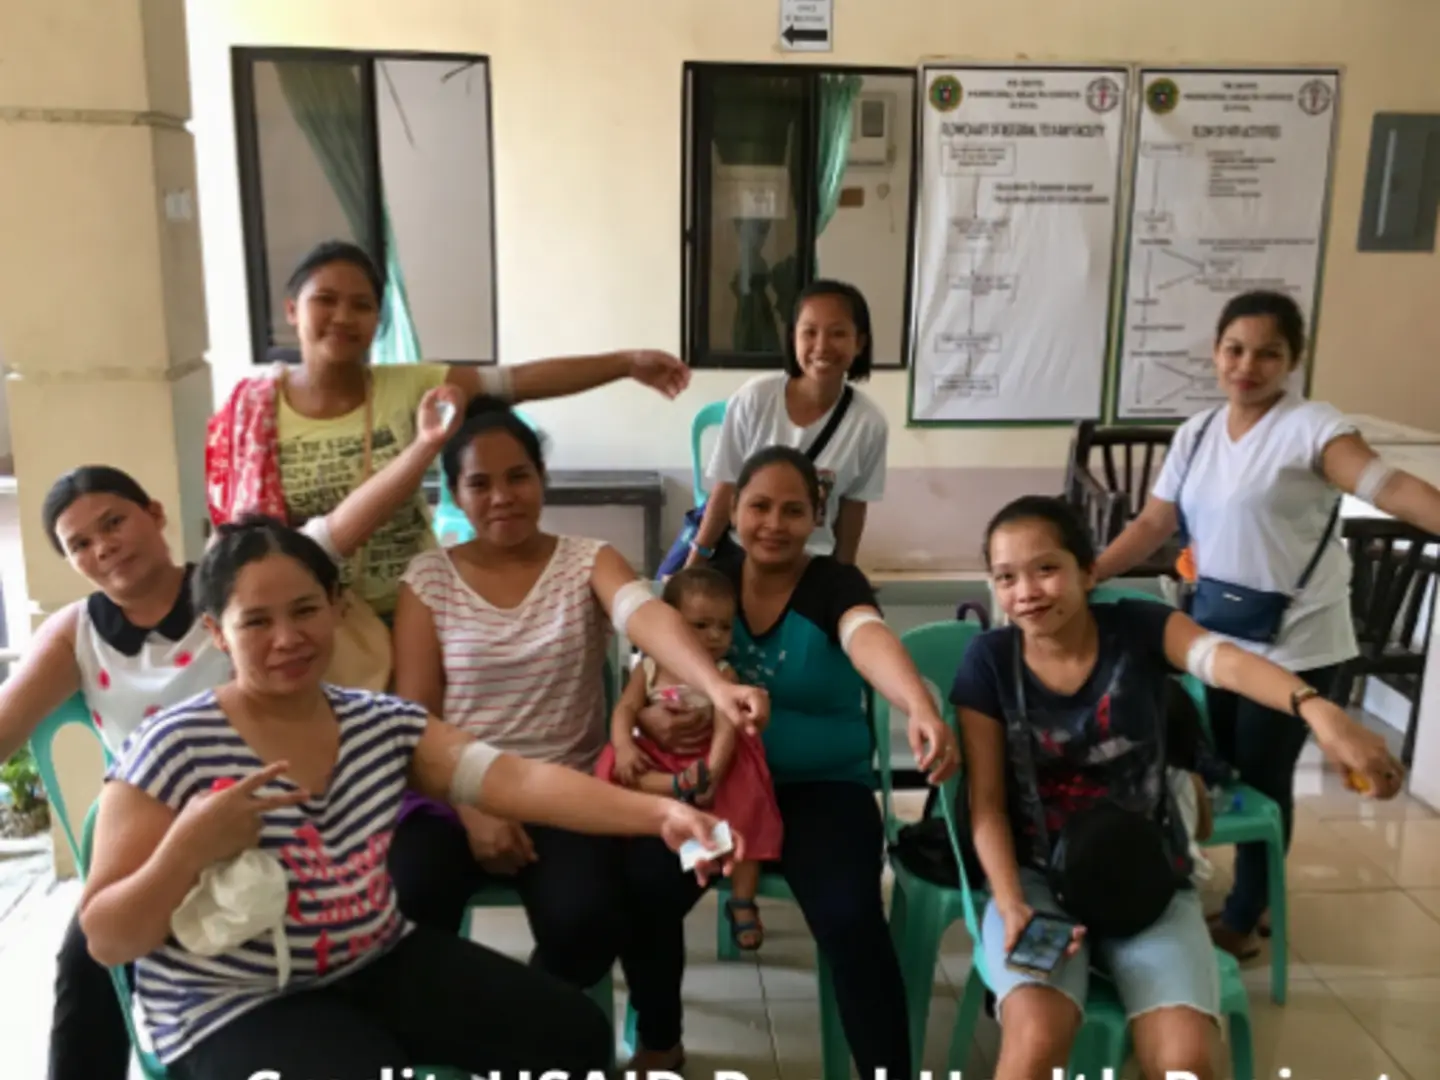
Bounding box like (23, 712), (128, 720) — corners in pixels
(390, 812), (701, 1050)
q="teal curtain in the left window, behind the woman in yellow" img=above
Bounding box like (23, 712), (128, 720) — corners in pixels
(275, 60), (420, 364)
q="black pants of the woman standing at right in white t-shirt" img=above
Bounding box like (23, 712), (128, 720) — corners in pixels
(1205, 665), (1339, 933)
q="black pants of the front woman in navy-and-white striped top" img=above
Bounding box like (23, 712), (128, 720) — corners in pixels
(170, 926), (615, 1080)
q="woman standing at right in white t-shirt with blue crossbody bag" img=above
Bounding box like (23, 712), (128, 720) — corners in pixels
(1096, 292), (1440, 959)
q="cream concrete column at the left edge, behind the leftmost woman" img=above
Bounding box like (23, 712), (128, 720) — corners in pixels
(0, 0), (212, 874)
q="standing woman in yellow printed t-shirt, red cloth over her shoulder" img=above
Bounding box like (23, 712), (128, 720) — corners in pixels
(206, 242), (688, 621)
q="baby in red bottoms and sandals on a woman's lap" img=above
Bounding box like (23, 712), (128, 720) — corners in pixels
(595, 566), (782, 950)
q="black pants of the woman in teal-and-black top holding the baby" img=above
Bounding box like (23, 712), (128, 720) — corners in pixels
(775, 782), (912, 1077)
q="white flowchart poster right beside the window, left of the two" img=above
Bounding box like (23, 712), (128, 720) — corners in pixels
(910, 65), (1129, 425)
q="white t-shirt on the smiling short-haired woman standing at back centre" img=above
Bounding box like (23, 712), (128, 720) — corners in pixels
(707, 372), (890, 554)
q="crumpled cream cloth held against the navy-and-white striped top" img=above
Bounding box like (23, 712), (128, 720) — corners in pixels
(170, 848), (289, 989)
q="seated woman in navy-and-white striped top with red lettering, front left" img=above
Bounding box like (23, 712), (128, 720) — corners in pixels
(81, 518), (731, 1080)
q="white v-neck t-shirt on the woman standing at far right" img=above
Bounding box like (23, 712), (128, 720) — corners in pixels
(1153, 395), (1359, 671)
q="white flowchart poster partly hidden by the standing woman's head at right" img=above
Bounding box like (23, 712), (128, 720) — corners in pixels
(1115, 69), (1339, 420)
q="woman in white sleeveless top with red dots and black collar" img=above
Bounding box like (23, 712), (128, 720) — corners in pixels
(0, 389), (455, 1080)
